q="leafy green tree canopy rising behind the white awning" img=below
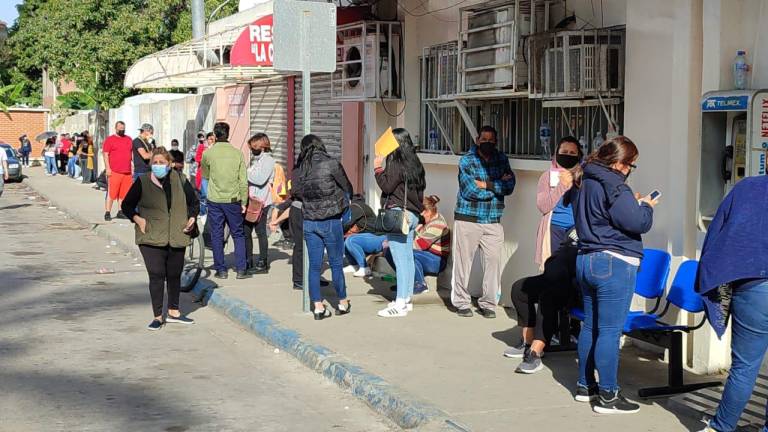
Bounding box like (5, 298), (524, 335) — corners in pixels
(0, 0), (237, 108)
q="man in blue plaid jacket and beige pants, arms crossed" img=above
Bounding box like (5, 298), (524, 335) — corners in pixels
(451, 126), (515, 318)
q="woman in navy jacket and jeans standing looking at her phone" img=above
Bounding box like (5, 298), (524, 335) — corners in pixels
(574, 136), (657, 414)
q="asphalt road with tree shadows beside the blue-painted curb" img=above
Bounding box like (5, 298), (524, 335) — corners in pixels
(0, 179), (395, 432)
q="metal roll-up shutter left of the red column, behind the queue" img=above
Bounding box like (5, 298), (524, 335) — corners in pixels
(251, 79), (288, 168)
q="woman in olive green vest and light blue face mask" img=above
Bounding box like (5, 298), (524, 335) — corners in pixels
(122, 147), (200, 330)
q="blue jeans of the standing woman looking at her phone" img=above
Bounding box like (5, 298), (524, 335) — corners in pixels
(576, 252), (637, 391)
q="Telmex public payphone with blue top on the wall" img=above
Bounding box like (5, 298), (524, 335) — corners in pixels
(697, 90), (768, 231)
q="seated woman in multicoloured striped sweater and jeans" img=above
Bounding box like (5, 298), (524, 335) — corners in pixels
(385, 195), (451, 294)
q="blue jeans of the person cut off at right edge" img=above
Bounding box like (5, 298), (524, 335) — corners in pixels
(709, 279), (768, 432)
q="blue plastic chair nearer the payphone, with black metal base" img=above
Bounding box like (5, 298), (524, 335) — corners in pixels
(624, 261), (721, 397)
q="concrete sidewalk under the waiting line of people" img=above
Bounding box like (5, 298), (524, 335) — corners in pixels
(26, 168), (711, 432)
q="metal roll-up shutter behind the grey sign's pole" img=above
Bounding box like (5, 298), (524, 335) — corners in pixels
(294, 74), (341, 159)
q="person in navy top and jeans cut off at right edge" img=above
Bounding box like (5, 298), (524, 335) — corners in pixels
(696, 172), (768, 432)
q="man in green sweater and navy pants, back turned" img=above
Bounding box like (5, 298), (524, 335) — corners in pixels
(200, 122), (250, 279)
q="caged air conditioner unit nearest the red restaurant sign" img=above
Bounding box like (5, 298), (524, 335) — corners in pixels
(332, 21), (404, 100)
